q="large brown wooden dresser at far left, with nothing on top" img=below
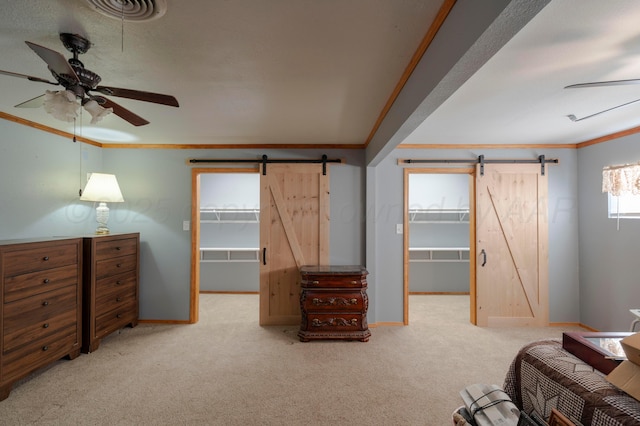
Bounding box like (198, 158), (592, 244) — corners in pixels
(0, 238), (82, 400)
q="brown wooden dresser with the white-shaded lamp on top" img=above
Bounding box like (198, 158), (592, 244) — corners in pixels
(82, 233), (140, 353)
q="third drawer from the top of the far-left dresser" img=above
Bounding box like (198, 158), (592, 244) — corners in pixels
(2, 286), (80, 334)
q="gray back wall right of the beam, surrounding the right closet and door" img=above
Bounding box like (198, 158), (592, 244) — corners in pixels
(367, 149), (580, 322)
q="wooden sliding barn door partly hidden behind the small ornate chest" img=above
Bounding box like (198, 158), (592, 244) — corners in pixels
(260, 164), (329, 325)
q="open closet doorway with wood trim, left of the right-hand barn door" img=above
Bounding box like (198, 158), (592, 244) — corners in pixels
(404, 168), (475, 324)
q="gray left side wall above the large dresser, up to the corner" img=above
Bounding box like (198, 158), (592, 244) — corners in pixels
(0, 120), (101, 239)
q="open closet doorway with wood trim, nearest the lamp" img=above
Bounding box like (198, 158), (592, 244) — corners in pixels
(190, 168), (260, 323)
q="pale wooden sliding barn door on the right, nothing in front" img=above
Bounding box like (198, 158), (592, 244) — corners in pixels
(475, 164), (549, 327)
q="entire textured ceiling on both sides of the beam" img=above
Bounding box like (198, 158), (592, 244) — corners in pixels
(0, 0), (640, 151)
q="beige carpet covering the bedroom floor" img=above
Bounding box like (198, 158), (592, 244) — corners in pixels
(0, 294), (577, 426)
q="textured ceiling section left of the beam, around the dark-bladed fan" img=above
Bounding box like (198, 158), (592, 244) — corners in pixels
(0, 0), (441, 145)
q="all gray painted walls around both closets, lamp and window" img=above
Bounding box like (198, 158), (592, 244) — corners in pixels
(7, 116), (640, 331)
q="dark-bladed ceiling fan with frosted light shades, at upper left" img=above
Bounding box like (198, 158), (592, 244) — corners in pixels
(0, 33), (179, 126)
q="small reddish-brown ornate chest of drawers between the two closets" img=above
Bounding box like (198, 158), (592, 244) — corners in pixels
(298, 265), (371, 342)
